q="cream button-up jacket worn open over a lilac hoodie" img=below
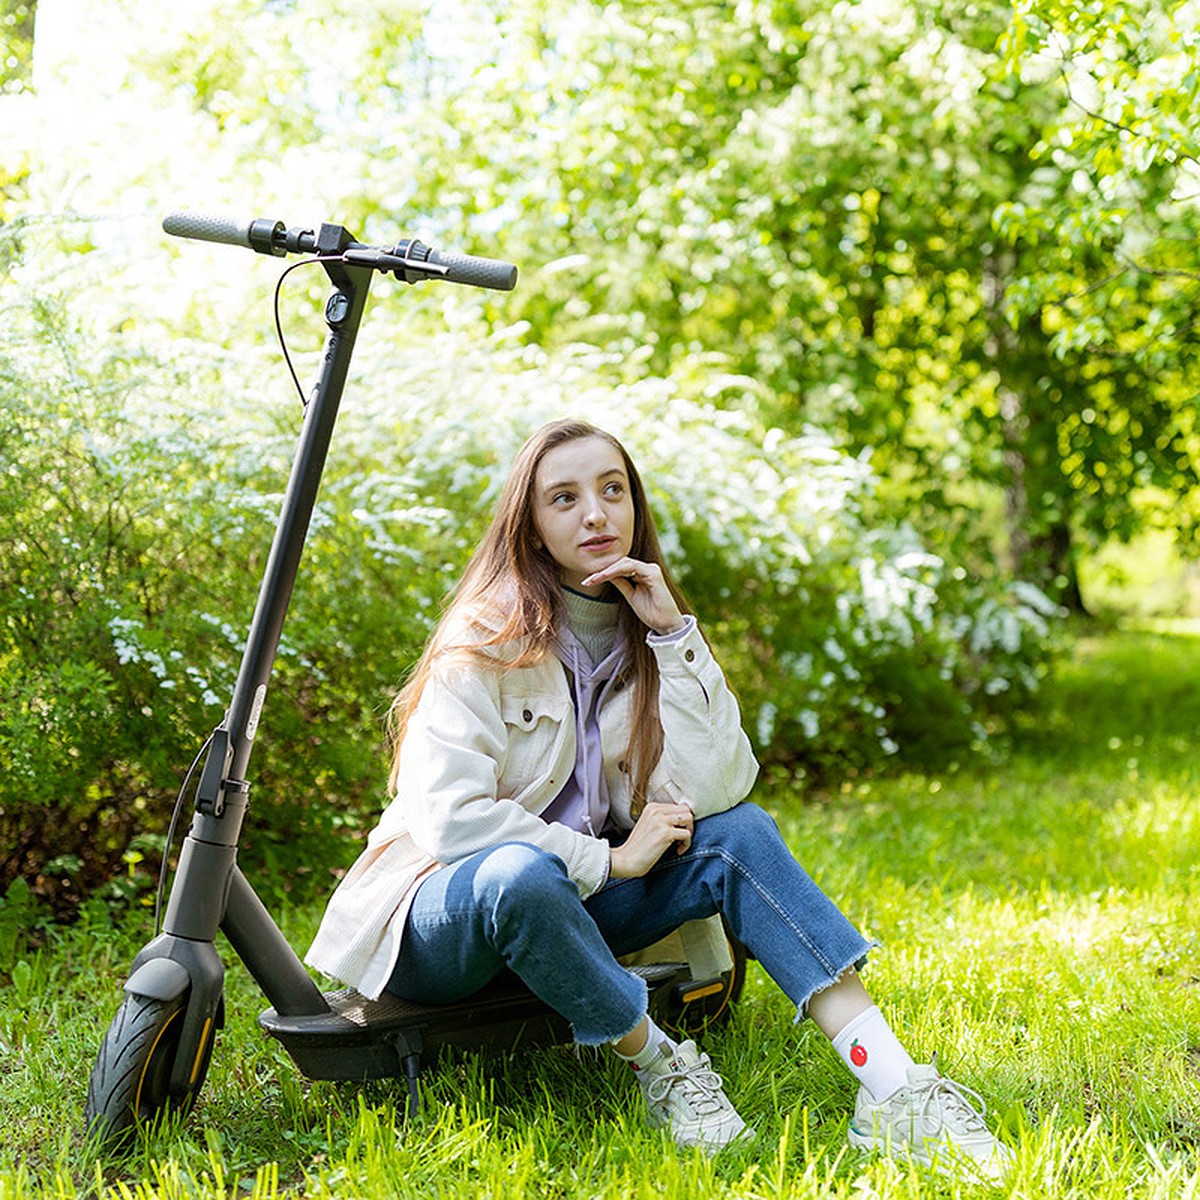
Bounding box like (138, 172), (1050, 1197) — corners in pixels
(305, 618), (758, 1000)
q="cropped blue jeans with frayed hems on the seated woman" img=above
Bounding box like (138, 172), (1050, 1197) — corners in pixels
(388, 803), (871, 1045)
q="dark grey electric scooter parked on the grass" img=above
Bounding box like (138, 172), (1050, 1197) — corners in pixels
(86, 212), (745, 1145)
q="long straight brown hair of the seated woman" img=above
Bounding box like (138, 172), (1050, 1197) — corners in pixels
(388, 420), (688, 812)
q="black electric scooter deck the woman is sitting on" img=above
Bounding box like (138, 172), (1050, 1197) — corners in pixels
(258, 962), (691, 1081)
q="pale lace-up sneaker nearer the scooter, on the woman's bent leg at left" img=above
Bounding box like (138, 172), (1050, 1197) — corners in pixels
(637, 1042), (754, 1153)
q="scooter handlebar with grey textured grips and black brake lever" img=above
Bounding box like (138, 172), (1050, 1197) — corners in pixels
(162, 211), (517, 292)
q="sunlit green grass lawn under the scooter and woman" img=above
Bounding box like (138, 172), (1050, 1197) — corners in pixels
(0, 634), (1200, 1200)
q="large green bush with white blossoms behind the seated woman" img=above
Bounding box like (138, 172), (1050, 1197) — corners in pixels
(0, 290), (1050, 906)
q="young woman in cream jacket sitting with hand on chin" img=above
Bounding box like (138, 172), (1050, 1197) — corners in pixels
(307, 421), (1009, 1177)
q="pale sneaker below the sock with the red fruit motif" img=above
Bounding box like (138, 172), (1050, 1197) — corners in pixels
(850, 1056), (1013, 1183)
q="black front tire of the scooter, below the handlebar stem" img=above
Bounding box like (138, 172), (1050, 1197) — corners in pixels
(86, 994), (215, 1144)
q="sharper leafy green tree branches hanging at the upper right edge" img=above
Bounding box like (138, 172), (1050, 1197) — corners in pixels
(997, 0), (1200, 545)
